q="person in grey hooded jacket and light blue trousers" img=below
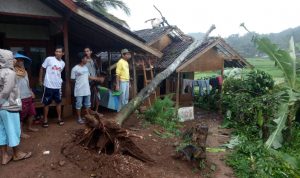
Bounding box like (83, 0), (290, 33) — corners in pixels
(0, 49), (31, 164)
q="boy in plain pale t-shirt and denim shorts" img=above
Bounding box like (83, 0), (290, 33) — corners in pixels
(71, 53), (103, 124)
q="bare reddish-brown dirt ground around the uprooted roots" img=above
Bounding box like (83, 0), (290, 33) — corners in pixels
(0, 110), (234, 178)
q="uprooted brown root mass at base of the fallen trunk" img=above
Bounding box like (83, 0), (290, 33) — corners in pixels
(77, 112), (154, 162)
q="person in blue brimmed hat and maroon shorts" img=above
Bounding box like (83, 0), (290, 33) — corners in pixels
(14, 53), (38, 138)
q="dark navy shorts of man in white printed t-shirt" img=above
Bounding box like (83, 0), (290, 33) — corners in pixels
(42, 87), (61, 106)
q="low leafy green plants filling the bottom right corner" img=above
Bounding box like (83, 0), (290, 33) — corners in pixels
(226, 139), (300, 178)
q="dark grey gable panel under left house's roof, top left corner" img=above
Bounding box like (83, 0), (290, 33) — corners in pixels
(0, 0), (61, 18)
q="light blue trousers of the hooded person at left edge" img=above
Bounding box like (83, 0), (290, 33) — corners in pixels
(0, 109), (21, 147)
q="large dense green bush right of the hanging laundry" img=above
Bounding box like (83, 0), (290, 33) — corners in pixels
(222, 70), (278, 130)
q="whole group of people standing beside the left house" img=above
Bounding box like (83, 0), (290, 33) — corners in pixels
(0, 46), (131, 165)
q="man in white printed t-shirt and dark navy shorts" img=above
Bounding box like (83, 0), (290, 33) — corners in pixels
(40, 46), (65, 128)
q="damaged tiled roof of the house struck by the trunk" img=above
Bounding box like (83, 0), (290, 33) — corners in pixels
(135, 26), (251, 69)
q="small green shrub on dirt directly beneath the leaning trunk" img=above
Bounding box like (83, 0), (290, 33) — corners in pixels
(144, 95), (178, 131)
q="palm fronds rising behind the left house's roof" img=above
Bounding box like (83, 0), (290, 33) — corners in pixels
(77, 0), (130, 27)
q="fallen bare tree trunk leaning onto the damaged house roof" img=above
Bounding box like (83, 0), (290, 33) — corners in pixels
(116, 25), (216, 125)
